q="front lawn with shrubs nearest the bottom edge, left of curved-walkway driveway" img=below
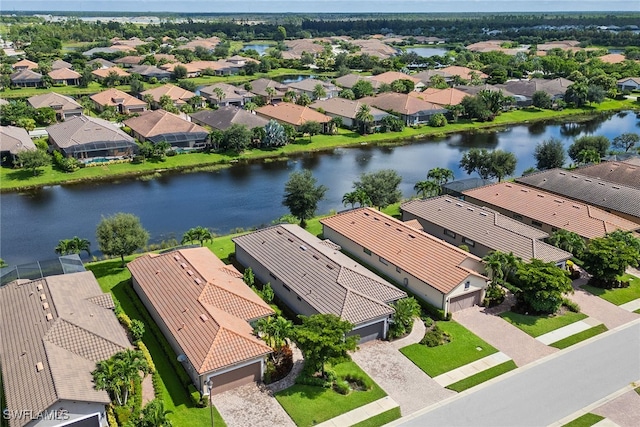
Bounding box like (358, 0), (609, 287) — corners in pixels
(276, 362), (386, 427)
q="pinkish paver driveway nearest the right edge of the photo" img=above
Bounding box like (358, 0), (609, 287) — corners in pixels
(568, 274), (638, 329)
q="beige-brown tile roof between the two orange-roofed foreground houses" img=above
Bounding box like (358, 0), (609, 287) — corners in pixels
(233, 224), (406, 325)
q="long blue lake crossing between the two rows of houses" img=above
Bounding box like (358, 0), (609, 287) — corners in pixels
(0, 113), (639, 264)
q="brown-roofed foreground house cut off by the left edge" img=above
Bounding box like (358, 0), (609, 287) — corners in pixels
(0, 271), (131, 427)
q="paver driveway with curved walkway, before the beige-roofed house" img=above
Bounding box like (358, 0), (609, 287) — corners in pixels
(351, 322), (456, 416)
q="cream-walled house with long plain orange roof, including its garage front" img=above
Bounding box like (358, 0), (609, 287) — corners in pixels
(320, 208), (489, 313)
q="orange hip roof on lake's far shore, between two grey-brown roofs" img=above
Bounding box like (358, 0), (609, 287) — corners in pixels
(124, 110), (209, 138)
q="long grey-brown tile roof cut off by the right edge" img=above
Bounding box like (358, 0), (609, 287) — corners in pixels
(516, 169), (640, 225)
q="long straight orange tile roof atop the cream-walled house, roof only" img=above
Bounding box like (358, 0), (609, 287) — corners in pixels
(320, 208), (484, 294)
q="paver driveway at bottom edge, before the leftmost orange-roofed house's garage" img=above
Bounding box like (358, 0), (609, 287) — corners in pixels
(212, 384), (295, 427)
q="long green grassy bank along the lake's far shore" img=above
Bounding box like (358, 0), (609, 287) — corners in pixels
(0, 100), (638, 192)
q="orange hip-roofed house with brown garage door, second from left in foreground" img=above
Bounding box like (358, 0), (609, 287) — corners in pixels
(127, 248), (274, 395)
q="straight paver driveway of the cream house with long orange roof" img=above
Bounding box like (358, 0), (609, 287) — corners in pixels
(453, 306), (558, 366)
